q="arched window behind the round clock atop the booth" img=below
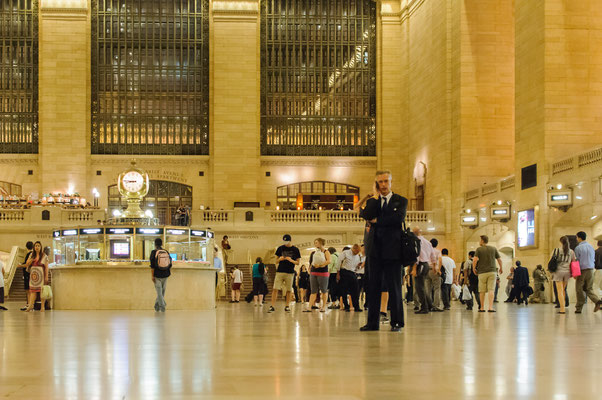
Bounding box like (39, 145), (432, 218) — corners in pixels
(109, 181), (192, 225)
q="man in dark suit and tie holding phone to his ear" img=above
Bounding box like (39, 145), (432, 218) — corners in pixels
(360, 171), (408, 332)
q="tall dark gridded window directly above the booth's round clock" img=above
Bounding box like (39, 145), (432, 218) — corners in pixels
(92, 0), (209, 155)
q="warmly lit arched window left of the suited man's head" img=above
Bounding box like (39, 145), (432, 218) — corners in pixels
(276, 181), (360, 210)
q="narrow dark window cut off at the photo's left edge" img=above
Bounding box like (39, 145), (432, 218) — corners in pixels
(0, 0), (38, 153)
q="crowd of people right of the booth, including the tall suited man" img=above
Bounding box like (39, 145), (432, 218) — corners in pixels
(225, 171), (602, 331)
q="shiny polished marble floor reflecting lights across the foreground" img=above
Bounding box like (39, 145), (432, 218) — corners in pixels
(0, 303), (602, 400)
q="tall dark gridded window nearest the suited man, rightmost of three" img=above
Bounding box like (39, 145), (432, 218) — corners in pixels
(261, 0), (376, 156)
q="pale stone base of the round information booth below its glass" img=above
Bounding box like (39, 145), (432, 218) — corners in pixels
(50, 261), (217, 310)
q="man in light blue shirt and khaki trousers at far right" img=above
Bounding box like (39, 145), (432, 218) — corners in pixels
(575, 232), (602, 314)
